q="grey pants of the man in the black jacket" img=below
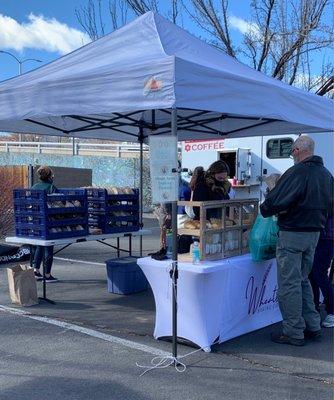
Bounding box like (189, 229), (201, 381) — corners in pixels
(276, 231), (321, 339)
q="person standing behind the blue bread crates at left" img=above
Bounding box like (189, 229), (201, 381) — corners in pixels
(31, 166), (58, 283)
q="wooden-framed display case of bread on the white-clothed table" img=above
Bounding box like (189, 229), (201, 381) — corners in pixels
(178, 199), (258, 260)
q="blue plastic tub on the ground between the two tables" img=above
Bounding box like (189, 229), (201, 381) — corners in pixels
(106, 257), (149, 294)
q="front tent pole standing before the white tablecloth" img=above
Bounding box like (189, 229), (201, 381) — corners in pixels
(171, 108), (178, 358)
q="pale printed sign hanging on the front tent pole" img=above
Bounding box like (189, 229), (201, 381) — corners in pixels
(149, 135), (178, 203)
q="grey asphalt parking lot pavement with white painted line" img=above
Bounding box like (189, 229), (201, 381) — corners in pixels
(0, 219), (334, 400)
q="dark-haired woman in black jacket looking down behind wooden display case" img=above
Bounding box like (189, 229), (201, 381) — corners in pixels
(192, 160), (231, 219)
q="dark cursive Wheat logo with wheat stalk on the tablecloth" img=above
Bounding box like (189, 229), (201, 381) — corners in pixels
(245, 263), (278, 315)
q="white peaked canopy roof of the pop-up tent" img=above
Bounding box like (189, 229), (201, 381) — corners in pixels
(0, 12), (333, 142)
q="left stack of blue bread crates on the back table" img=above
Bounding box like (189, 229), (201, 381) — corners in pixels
(13, 189), (88, 240)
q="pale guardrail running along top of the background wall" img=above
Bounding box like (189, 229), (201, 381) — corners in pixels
(0, 141), (149, 157)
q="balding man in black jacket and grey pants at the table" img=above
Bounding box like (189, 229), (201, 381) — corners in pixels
(260, 135), (333, 346)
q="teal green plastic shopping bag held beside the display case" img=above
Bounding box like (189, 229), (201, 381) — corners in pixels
(249, 214), (278, 261)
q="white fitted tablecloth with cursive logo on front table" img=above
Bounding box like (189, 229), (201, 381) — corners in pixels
(138, 254), (282, 351)
